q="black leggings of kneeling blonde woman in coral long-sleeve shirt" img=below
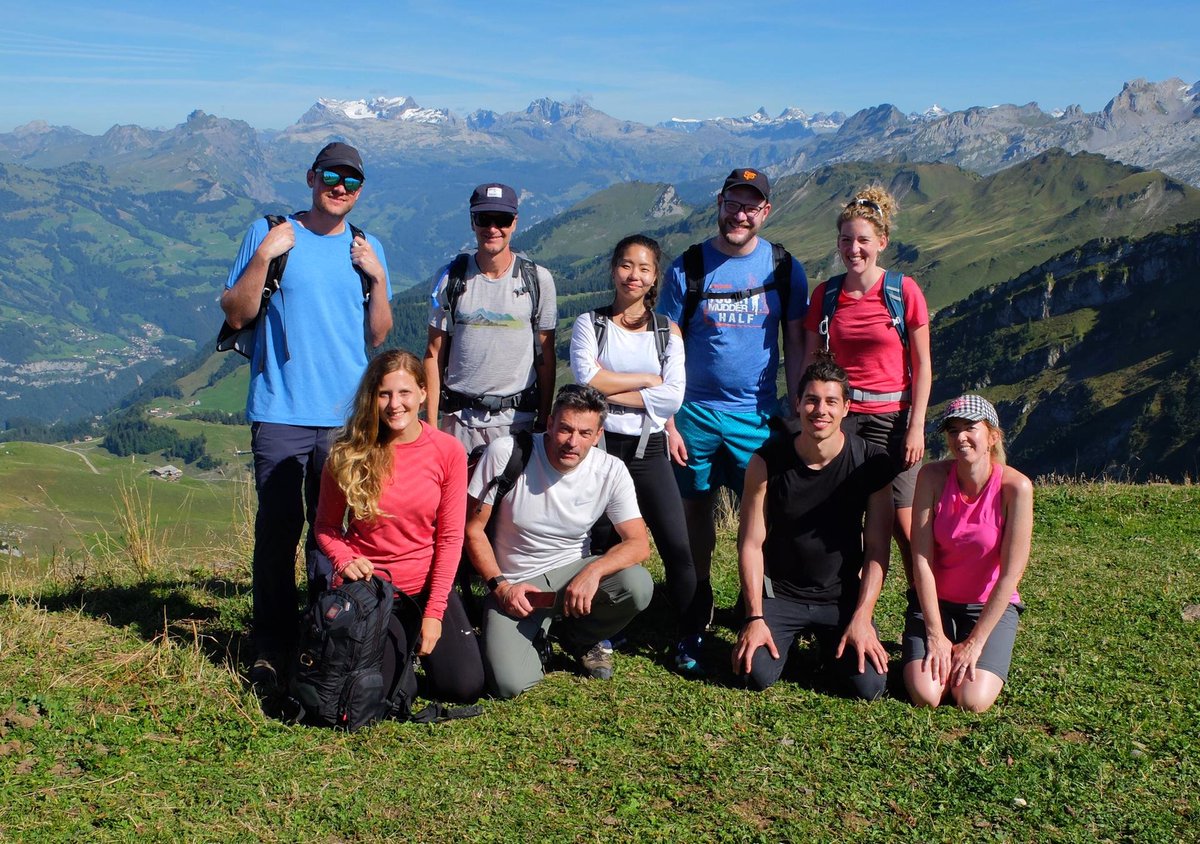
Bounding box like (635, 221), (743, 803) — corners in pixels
(383, 589), (484, 704)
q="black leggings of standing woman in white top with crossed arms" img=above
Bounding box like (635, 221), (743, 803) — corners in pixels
(592, 431), (713, 636)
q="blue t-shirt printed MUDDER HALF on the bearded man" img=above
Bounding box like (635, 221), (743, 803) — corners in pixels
(659, 238), (809, 413)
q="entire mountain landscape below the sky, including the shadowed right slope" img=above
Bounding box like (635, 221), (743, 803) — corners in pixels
(0, 79), (1200, 492)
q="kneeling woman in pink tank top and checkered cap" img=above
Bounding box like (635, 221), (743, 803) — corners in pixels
(902, 395), (1033, 712)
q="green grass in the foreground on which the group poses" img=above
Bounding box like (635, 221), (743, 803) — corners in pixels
(0, 484), (1200, 842)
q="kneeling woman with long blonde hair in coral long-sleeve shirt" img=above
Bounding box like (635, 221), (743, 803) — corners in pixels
(316, 349), (484, 702)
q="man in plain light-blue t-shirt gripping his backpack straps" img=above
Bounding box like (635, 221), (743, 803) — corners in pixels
(221, 142), (391, 690)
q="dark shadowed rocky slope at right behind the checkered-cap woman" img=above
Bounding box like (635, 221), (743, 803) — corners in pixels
(931, 223), (1200, 480)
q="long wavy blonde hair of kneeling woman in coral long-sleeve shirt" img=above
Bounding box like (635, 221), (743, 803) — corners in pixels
(325, 349), (425, 521)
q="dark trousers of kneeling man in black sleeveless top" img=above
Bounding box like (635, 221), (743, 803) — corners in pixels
(750, 597), (888, 700)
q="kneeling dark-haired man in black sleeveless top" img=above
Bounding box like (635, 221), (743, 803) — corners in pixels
(733, 360), (893, 700)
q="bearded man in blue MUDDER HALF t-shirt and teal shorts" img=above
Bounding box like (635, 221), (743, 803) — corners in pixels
(659, 167), (809, 633)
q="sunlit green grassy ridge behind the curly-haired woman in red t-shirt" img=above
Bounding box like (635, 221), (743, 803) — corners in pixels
(768, 150), (1200, 309)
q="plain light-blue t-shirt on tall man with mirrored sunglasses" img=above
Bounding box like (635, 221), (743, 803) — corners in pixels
(226, 216), (391, 427)
